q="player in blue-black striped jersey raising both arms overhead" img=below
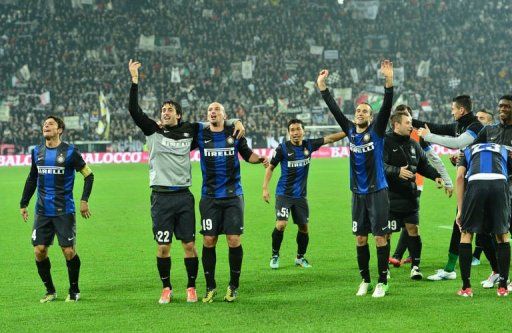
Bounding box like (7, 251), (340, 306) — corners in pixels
(317, 60), (393, 297)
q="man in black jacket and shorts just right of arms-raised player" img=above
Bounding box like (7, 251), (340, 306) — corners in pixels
(384, 111), (444, 280)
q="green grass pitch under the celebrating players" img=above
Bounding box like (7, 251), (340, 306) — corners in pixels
(0, 159), (512, 332)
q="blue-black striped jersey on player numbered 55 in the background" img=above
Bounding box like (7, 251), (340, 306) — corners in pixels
(270, 138), (324, 198)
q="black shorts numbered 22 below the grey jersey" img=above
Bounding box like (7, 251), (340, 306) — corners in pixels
(151, 189), (196, 244)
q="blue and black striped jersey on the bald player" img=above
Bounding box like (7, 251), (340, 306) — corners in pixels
(197, 124), (252, 198)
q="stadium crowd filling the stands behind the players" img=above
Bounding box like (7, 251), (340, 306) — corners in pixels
(0, 0), (512, 154)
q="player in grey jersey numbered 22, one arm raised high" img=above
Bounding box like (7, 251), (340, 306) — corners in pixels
(128, 60), (244, 304)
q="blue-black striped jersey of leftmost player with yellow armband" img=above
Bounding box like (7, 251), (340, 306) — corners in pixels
(29, 142), (86, 216)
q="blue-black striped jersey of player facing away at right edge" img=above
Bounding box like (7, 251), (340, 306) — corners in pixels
(459, 143), (510, 181)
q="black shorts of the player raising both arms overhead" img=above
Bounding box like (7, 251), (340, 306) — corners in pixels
(352, 188), (391, 236)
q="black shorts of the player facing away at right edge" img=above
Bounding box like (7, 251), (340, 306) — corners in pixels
(461, 180), (510, 235)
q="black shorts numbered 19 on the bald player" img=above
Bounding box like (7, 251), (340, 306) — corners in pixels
(199, 196), (244, 236)
